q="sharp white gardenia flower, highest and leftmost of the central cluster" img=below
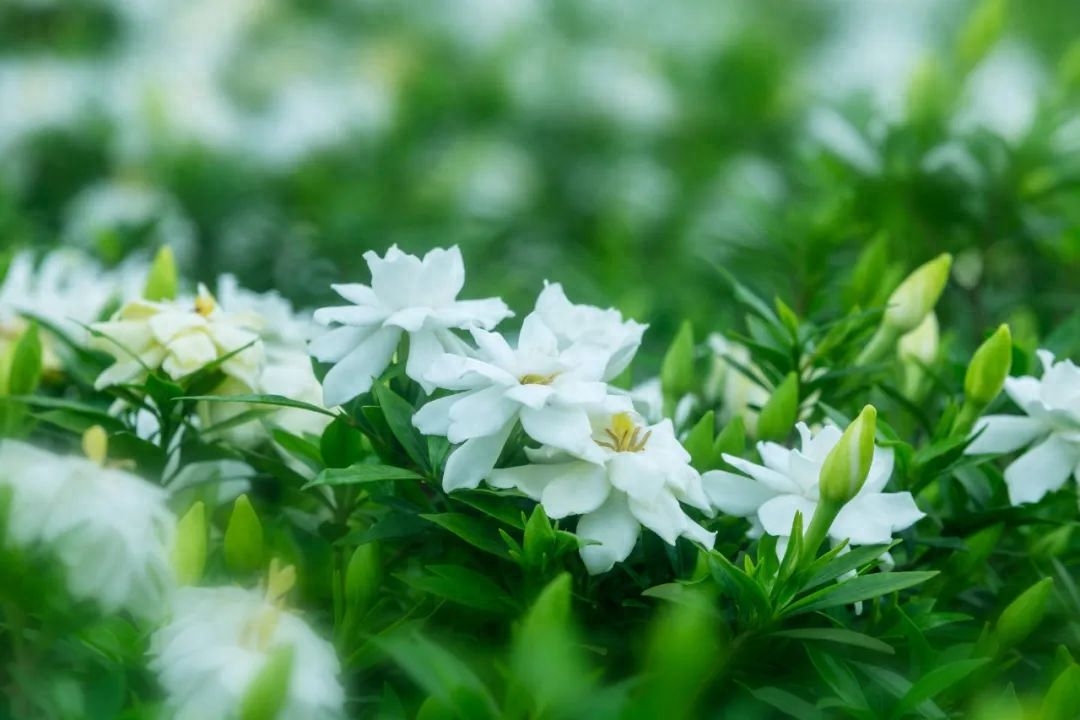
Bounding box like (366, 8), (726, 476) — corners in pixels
(311, 245), (513, 407)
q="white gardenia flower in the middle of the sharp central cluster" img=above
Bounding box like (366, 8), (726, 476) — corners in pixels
(413, 313), (631, 491)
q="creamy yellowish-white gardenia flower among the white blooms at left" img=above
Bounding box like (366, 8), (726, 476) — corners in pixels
(91, 287), (264, 390)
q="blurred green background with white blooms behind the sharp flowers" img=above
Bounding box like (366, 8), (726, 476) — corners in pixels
(0, 0), (1080, 367)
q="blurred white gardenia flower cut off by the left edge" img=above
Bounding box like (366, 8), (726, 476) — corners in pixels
(0, 440), (176, 620)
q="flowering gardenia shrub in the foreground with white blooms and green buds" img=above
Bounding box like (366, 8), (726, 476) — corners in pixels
(0, 241), (1080, 720)
